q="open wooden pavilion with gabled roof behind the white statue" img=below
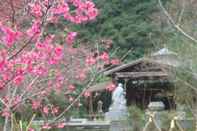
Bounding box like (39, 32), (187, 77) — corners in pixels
(87, 58), (175, 109)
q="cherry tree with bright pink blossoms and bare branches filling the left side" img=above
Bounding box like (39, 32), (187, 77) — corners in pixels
(0, 0), (119, 131)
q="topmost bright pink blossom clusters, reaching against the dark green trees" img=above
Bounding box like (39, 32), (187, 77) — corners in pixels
(29, 0), (98, 24)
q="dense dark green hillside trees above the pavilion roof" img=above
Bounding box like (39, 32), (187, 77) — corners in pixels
(67, 0), (165, 59)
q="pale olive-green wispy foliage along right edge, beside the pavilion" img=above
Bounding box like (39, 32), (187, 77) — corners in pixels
(163, 0), (197, 106)
